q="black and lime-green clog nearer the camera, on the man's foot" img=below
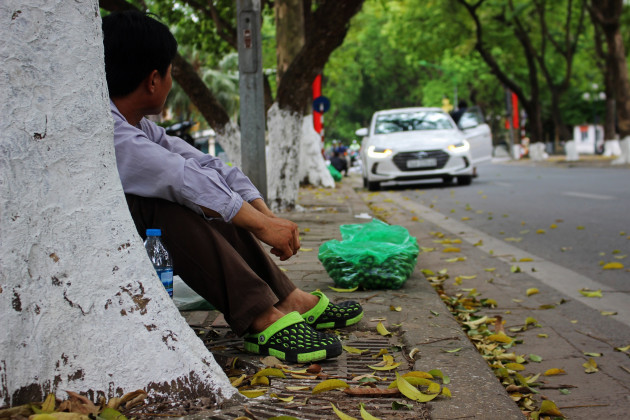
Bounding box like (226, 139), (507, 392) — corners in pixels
(244, 312), (342, 363)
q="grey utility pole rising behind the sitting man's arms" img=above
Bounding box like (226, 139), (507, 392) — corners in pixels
(236, 0), (267, 199)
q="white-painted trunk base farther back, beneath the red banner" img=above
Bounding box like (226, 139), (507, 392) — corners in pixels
(298, 114), (335, 188)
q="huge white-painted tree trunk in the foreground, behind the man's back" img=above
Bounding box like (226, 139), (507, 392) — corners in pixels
(0, 0), (238, 406)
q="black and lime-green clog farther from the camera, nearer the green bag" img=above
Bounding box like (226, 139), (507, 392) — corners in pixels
(302, 291), (363, 330)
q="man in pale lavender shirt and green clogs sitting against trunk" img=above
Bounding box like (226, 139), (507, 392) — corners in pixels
(103, 12), (363, 362)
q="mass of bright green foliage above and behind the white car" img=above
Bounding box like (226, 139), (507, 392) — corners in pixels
(324, 0), (630, 146)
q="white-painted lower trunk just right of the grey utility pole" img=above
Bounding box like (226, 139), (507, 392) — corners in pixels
(267, 102), (302, 211)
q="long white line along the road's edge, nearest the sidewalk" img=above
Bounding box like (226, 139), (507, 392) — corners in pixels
(381, 193), (630, 326)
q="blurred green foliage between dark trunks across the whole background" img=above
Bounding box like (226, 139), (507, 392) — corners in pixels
(105, 0), (630, 144)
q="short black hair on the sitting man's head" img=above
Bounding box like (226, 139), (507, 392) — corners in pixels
(103, 10), (177, 97)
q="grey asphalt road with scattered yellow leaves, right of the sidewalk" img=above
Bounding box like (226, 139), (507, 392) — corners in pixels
(361, 162), (630, 418)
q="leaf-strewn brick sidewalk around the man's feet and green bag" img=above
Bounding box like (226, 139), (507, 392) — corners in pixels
(183, 175), (524, 420)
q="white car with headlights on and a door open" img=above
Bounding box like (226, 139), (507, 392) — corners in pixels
(356, 107), (492, 191)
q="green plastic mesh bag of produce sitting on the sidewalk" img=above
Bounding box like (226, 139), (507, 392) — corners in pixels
(318, 219), (419, 289)
